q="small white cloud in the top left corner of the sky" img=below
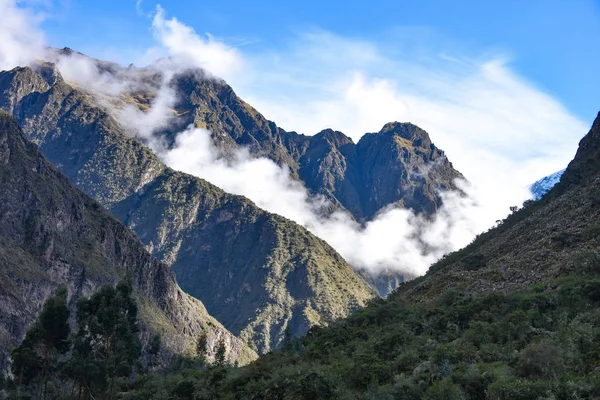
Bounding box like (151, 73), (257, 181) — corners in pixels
(0, 0), (44, 71)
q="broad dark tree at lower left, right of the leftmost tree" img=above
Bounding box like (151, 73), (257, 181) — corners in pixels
(68, 281), (141, 399)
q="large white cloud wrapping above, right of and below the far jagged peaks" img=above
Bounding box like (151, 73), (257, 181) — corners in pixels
(120, 10), (587, 273)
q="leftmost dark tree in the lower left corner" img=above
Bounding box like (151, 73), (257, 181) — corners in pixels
(11, 288), (70, 399)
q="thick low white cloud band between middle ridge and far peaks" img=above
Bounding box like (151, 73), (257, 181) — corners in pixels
(155, 126), (479, 274)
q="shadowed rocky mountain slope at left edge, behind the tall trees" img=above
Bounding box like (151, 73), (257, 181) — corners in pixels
(0, 110), (256, 369)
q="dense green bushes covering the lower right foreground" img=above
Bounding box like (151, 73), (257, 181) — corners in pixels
(8, 266), (600, 400)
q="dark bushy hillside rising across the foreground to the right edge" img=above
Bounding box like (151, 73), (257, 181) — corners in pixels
(119, 114), (600, 400)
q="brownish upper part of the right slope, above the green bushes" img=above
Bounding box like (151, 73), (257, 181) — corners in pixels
(399, 111), (600, 300)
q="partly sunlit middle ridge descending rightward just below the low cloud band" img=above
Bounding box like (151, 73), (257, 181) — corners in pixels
(0, 63), (375, 352)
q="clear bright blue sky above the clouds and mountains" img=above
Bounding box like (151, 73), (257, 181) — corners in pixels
(42, 0), (600, 121)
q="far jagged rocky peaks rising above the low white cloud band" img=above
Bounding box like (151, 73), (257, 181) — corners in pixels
(152, 66), (463, 221)
